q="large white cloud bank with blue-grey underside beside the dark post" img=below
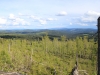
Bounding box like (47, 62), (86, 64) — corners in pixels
(70, 11), (100, 26)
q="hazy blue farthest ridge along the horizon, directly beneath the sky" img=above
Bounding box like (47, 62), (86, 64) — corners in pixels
(0, 28), (97, 33)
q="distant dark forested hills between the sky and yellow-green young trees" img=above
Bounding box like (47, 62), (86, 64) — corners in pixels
(0, 28), (97, 40)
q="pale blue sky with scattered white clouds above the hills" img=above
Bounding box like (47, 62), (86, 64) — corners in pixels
(0, 0), (100, 29)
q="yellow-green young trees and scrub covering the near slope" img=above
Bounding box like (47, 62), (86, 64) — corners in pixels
(0, 35), (97, 75)
